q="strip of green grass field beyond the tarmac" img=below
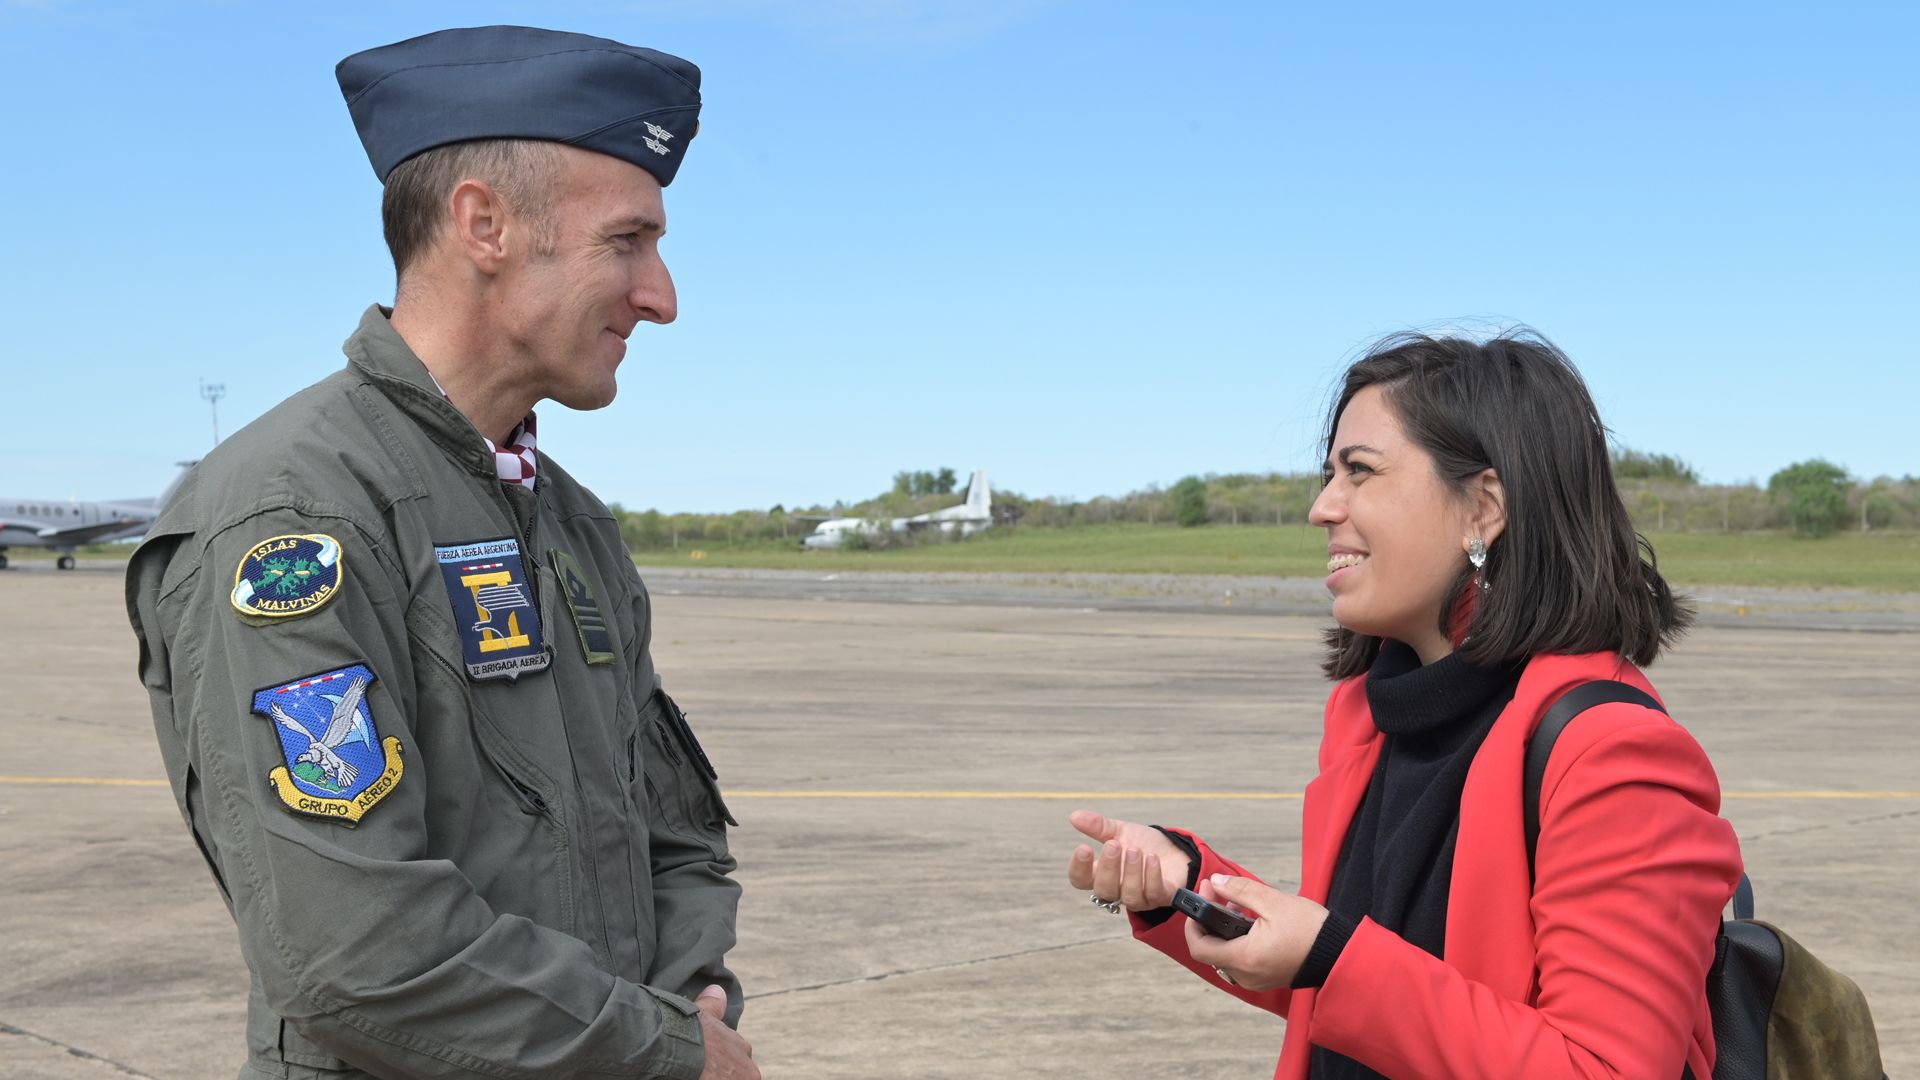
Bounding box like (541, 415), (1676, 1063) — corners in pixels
(634, 525), (1920, 592)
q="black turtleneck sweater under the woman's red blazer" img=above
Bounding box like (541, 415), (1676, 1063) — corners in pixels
(1294, 642), (1523, 1080)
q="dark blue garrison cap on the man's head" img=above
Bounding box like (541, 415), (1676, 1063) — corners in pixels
(334, 27), (701, 186)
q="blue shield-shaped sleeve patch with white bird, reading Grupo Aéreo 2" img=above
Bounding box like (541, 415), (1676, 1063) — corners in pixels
(253, 663), (401, 826)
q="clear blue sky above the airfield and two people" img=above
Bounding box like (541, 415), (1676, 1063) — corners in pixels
(0, 0), (1920, 511)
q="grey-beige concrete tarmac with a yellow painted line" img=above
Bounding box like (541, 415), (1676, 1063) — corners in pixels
(0, 563), (1920, 1080)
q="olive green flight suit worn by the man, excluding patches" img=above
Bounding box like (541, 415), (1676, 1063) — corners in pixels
(127, 306), (741, 1080)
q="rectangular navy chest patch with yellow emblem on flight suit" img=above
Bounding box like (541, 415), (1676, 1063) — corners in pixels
(434, 536), (553, 680)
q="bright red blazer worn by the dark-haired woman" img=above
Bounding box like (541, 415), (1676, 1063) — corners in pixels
(1133, 653), (1740, 1080)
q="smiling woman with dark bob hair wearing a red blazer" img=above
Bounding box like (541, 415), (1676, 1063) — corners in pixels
(1068, 332), (1740, 1080)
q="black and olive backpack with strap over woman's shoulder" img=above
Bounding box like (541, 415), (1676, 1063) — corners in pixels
(1524, 680), (1887, 1080)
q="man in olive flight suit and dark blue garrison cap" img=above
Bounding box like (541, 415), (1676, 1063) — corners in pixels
(127, 27), (758, 1080)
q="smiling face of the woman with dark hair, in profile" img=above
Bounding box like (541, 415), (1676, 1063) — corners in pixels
(1309, 386), (1505, 663)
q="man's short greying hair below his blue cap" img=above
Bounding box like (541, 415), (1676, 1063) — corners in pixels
(380, 138), (561, 277)
